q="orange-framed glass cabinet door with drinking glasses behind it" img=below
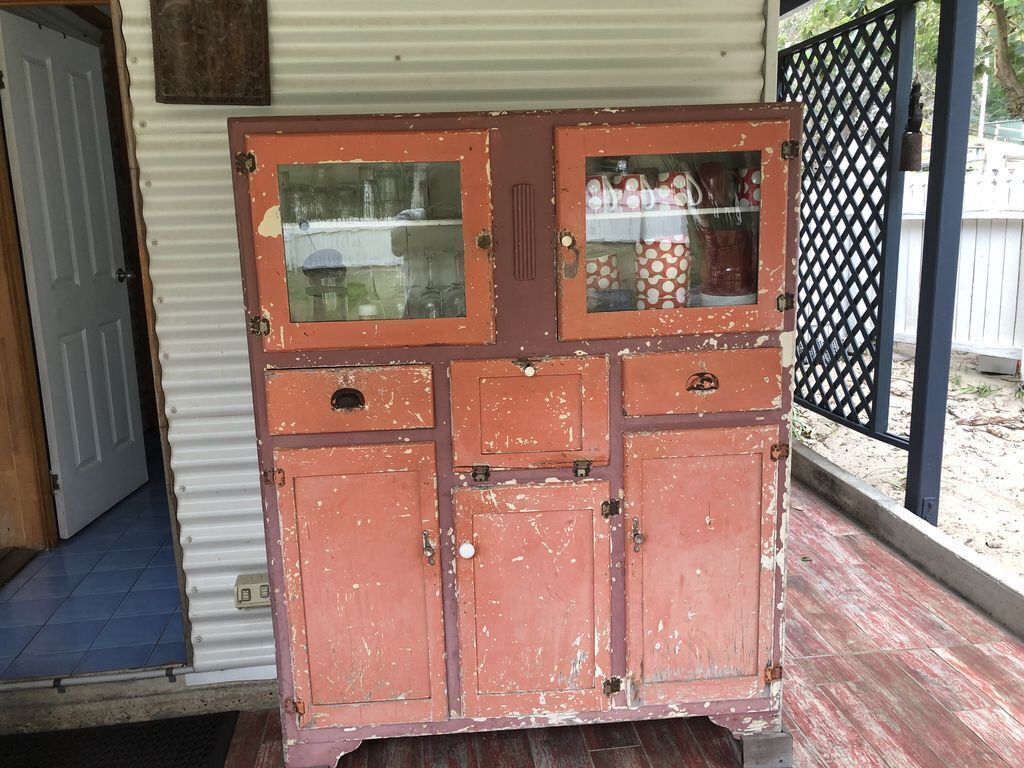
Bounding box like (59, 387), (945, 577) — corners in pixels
(247, 131), (494, 350)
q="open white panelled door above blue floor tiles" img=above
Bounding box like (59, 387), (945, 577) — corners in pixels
(0, 12), (146, 539)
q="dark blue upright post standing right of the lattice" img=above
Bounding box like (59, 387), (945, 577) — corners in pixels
(904, 0), (978, 524)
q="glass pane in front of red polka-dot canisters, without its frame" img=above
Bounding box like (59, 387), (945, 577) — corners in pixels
(586, 152), (761, 312)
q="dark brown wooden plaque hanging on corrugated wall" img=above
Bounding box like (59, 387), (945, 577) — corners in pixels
(150, 0), (270, 104)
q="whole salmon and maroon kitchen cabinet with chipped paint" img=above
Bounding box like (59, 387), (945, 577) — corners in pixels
(228, 104), (800, 768)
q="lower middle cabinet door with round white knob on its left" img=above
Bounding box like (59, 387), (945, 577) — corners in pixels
(455, 481), (611, 717)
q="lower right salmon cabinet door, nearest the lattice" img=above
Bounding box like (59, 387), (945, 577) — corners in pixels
(624, 426), (778, 705)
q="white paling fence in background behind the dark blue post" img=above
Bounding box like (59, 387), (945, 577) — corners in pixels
(895, 168), (1024, 359)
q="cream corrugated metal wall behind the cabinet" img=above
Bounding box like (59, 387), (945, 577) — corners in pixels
(122, 0), (778, 671)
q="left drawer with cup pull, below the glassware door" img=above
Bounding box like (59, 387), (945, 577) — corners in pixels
(266, 366), (434, 434)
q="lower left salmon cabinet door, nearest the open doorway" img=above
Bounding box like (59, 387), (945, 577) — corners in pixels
(274, 443), (446, 727)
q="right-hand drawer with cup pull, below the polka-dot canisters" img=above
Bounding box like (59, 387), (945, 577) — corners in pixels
(623, 348), (782, 416)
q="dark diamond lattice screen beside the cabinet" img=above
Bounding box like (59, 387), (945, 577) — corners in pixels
(778, 2), (913, 444)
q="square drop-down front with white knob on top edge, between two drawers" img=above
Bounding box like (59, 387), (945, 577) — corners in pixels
(452, 356), (608, 469)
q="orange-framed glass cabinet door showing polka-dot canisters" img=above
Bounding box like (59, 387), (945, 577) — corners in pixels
(555, 122), (790, 339)
